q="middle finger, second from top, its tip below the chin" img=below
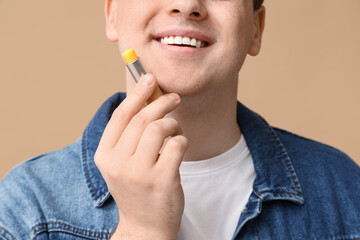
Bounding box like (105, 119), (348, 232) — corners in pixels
(115, 93), (180, 158)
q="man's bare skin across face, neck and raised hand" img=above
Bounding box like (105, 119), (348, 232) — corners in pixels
(95, 0), (265, 240)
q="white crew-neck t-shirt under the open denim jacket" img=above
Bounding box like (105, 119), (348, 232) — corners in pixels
(176, 136), (256, 240)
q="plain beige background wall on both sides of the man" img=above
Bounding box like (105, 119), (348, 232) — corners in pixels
(0, 0), (360, 178)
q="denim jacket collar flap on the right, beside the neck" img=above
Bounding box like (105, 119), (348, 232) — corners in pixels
(237, 102), (304, 205)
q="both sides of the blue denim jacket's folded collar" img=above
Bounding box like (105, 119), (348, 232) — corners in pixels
(81, 93), (304, 207)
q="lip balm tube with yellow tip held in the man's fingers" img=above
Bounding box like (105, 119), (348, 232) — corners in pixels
(122, 48), (163, 104)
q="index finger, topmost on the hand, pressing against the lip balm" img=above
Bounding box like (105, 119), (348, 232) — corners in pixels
(99, 74), (156, 151)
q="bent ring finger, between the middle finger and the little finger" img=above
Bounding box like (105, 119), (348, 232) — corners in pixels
(133, 118), (182, 167)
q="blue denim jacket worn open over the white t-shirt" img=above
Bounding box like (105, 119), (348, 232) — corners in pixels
(0, 93), (360, 240)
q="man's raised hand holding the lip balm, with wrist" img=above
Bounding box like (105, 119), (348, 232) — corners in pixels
(95, 74), (188, 240)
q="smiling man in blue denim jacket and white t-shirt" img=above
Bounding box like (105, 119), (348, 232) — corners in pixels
(0, 0), (360, 240)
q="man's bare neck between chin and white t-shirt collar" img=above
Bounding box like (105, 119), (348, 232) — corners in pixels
(168, 79), (241, 161)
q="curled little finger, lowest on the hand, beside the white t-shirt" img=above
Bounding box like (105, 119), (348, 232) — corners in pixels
(156, 135), (188, 178)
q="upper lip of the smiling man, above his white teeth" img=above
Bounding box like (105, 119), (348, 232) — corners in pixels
(152, 29), (214, 45)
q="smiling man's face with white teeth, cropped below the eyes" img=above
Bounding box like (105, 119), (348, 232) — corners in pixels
(106, 0), (264, 95)
